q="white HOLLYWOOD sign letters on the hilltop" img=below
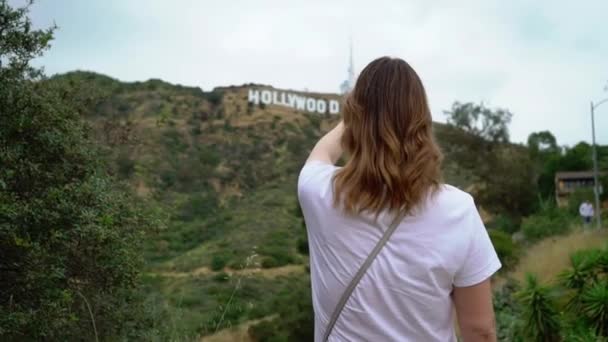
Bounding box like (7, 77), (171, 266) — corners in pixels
(249, 89), (340, 114)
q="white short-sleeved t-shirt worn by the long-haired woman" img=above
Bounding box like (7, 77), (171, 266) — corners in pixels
(298, 161), (501, 342)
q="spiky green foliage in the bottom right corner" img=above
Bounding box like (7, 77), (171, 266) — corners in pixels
(508, 248), (608, 341)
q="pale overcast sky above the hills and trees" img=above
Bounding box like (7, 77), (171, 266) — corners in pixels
(15, 0), (608, 145)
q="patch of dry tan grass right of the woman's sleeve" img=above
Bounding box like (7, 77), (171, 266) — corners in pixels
(510, 228), (608, 284)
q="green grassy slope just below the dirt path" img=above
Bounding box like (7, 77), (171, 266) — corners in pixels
(144, 272), (308, 340)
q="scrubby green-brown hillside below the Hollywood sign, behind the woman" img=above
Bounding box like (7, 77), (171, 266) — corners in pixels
(50, 72), (490, 338)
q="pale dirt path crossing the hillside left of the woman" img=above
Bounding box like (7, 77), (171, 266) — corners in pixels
(148, 265), (305, 278)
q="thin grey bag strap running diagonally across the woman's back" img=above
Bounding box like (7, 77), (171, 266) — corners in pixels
(322, 214), (404, 341)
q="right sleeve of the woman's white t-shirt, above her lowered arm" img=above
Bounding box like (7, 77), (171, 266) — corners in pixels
(454, 201), (502, 287)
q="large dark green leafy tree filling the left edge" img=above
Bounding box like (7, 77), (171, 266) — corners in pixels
(0, 0), (162, 340)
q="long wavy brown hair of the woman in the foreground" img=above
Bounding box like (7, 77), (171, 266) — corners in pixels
(334, 57), (442, 217)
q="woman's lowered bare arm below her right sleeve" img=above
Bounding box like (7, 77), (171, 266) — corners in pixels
(452, 279), (496, 342)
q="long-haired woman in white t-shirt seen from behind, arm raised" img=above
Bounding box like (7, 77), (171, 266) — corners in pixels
(298, 57), (501, 342)
